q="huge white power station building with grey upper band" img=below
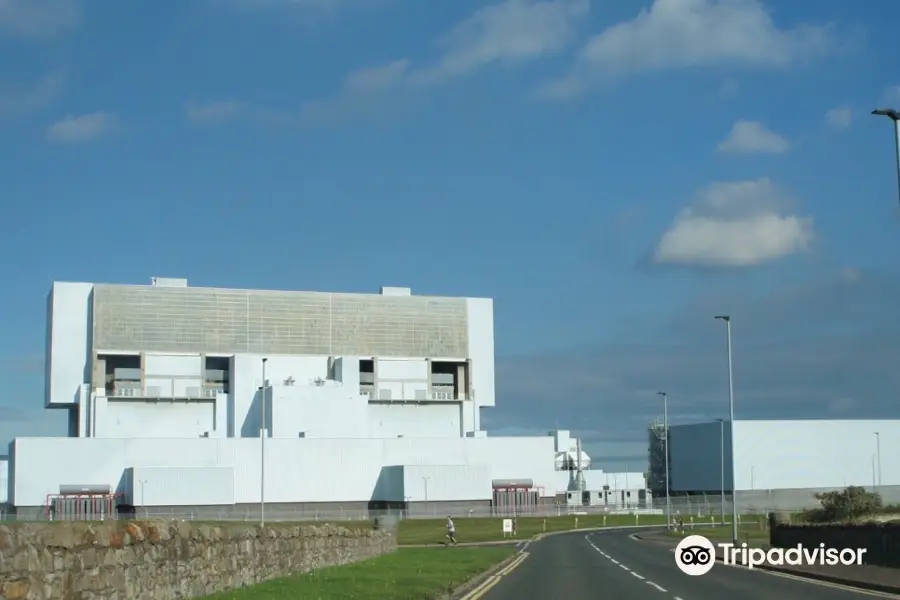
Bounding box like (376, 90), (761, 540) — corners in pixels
(8, 278), (646, 514)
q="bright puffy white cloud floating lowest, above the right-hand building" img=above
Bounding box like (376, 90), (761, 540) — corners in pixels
(653, 179), (815, 267)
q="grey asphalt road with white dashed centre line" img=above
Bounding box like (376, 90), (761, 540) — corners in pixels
(482, 531), (894, 600)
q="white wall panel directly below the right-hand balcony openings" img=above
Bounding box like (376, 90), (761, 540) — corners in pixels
(370, 403), (461, 438)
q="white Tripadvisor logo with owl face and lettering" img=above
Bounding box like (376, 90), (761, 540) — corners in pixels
(675, 535), (866, 576)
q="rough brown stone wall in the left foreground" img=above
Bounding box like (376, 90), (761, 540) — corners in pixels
(0, 521), (397, 600)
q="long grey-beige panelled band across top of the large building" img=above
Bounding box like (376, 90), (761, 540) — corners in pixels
(93, 285), (469, 358)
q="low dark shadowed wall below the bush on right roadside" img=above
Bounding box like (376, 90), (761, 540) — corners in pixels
(769, 513), (900, 568)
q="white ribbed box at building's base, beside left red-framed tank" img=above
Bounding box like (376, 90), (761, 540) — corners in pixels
(132, 467), (234, 506)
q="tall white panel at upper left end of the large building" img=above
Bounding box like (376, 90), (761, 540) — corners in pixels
(44, 282), (94, 406)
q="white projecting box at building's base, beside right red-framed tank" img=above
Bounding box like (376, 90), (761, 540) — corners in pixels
(403, 465), (493, 502)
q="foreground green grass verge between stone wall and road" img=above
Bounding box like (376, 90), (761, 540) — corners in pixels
(205, 547), (515, 600)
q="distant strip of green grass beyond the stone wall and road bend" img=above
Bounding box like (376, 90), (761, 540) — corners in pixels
(397, 515), (666, 546)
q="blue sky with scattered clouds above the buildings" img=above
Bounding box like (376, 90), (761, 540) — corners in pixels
(0, 0), (900, 468)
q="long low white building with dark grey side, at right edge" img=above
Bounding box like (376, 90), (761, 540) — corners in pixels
(669, 420), (900, 510)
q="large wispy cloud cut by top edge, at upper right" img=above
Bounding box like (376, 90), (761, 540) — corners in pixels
(540, 0), (833, 98)
